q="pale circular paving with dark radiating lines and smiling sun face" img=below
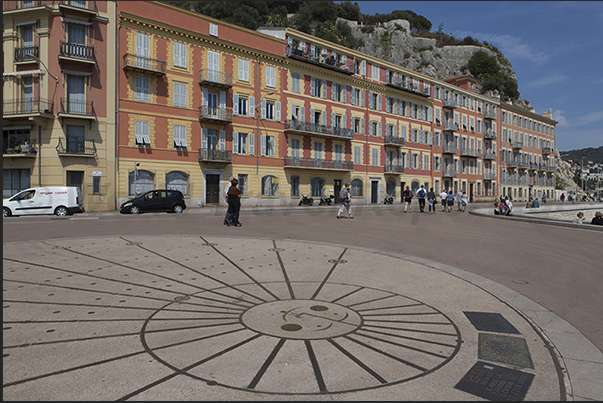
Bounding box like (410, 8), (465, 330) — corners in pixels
(3, 236), (559, 400)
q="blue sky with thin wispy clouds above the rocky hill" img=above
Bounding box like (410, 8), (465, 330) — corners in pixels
(352, 1), (603, 151)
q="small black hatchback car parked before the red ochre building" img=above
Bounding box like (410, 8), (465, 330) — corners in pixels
(119, 189), (186, 214)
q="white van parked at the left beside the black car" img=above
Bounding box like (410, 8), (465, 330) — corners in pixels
(2, 186), (84, 217)
